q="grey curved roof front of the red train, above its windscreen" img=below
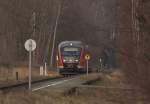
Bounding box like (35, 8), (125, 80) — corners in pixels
(58, 41), (83, 48)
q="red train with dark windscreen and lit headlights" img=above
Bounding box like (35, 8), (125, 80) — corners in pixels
(57, 41), (86, 74)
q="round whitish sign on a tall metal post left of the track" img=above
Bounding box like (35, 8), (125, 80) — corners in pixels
(25, 39), (36, 90)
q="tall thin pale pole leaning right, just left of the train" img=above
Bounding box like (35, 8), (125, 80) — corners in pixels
(50, 3), (62, 67)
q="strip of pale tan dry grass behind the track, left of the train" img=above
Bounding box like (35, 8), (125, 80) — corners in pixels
(0, 67), (58, 85)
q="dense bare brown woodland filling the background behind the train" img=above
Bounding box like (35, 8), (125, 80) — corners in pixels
(0, 0), (150, 94)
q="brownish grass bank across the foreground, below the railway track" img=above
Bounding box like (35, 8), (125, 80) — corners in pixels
(0, 71), (150, 104)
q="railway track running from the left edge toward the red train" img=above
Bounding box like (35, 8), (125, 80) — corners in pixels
(0, 75), (78, 93)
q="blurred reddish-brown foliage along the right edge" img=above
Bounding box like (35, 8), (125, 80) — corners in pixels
(120, 0), (150, 95)
